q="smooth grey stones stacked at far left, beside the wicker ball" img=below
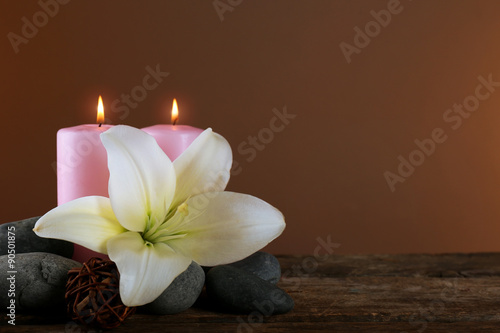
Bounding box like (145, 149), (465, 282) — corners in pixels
(0, 217), (78, 313)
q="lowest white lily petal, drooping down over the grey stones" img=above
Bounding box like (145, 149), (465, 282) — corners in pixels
(108, 231), (191, 306)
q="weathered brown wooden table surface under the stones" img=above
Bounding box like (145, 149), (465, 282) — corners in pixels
(0, 253), (500, 333)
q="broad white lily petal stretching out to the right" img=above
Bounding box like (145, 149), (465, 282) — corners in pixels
(167, 192), (285, 266)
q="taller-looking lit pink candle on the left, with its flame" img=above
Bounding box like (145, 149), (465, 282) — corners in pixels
(57, 96), (112, 262)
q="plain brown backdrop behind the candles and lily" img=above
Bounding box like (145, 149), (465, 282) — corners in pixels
(0, 0), (500, 253)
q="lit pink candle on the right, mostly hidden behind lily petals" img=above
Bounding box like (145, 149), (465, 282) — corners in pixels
(142, 99), (203, 161)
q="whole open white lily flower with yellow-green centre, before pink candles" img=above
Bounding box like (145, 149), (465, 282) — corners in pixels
(34, 125), (285, 306)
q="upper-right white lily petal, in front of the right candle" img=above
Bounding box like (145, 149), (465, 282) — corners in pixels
(172, 128), (233, 207)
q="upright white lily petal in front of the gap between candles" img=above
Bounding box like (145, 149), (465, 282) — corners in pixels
(101, 125), (175, 232)
